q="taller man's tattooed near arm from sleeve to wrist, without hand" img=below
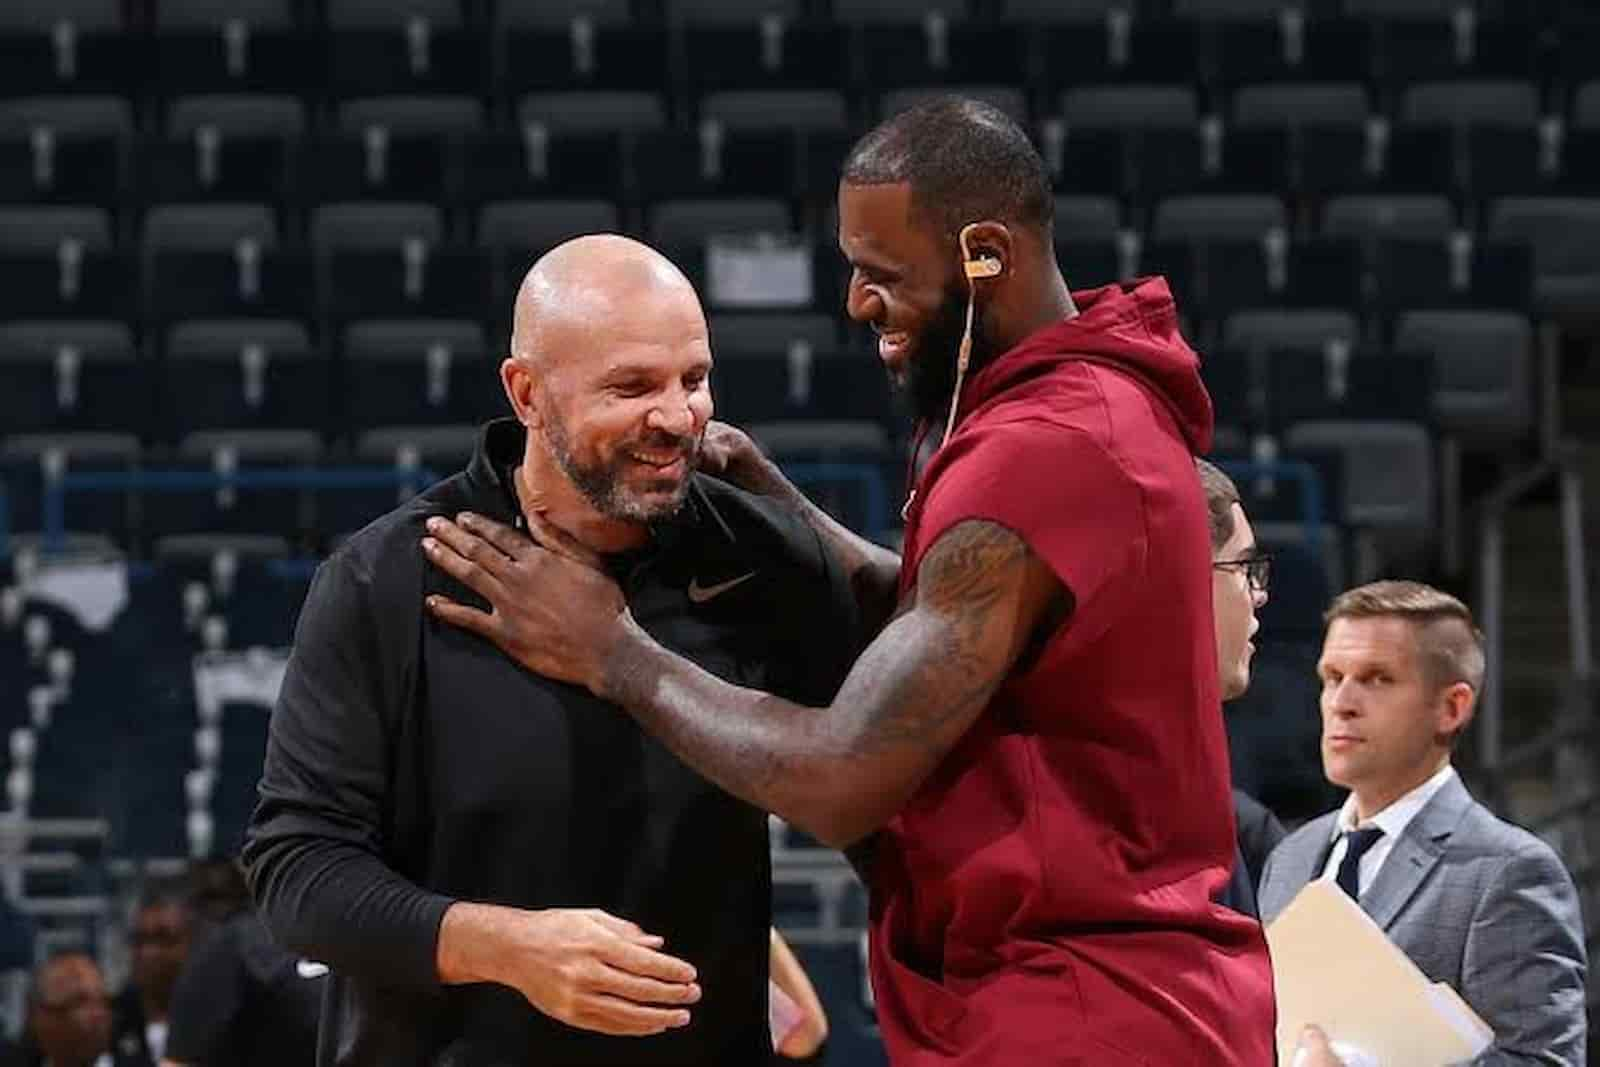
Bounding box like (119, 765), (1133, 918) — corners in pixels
(598, 520), (1066, 848)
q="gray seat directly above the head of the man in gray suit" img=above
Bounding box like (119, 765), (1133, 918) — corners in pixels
(1285, 421), (1435, 530)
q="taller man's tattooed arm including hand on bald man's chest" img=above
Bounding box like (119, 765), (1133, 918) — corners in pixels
(422, 512), (1070, 848)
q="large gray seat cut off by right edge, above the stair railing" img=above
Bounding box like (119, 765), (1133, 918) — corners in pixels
(1490, 197), (1600, 318)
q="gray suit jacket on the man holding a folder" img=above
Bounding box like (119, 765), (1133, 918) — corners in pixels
(1261, 777), (1587, 1067)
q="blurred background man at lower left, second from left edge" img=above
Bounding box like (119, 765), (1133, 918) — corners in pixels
(112, 881), (194, 1064)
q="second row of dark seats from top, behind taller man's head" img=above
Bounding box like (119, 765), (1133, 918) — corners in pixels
(9, 102), (1600, 208)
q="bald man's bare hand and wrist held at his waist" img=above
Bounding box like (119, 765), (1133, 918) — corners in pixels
(438, 904), (701, 1037)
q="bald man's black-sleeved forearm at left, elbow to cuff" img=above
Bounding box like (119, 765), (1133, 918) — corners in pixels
(248, 837), (451, 989)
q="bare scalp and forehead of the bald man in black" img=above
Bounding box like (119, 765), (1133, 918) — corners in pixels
(510, 234), (706, 368)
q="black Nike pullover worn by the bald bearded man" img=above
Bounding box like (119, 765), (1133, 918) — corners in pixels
(245, 419), (858, 1067)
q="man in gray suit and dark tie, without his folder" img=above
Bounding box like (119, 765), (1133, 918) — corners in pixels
(1261, 582), (1587, 1067)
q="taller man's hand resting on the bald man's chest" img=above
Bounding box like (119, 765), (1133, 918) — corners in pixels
(422, 512), (637, 691)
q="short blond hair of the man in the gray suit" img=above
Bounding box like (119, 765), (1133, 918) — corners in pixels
(1322, 581), (1485, 693)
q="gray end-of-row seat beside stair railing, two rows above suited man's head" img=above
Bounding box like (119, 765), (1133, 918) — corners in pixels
(1395, 310), (1533, 440)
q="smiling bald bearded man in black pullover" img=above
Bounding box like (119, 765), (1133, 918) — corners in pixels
(245, 237), (858, 1067)
